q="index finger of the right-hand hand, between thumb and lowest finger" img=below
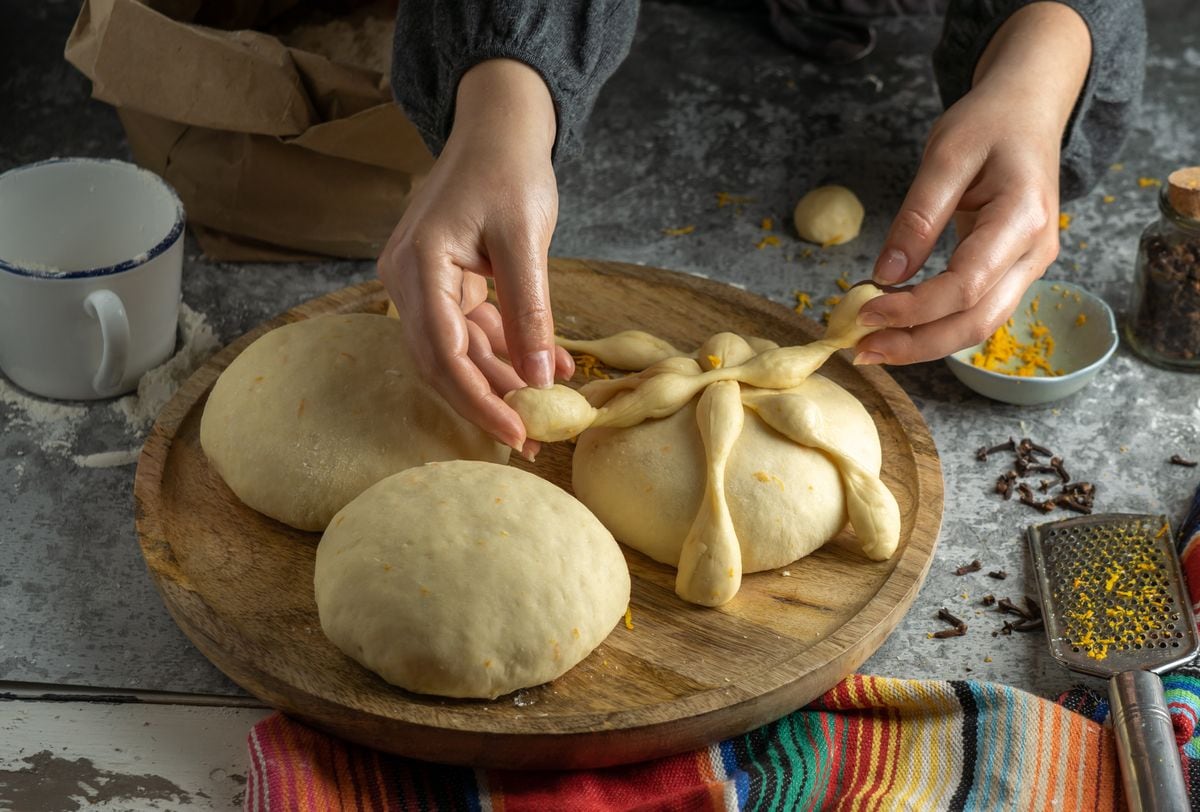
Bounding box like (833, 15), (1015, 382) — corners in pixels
(859, 190), (1057, 327)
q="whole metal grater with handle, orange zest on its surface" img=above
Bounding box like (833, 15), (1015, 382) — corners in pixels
(1028, 513), (1200, 810)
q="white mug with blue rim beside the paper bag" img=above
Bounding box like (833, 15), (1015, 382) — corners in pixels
(0, 158), (184, 401)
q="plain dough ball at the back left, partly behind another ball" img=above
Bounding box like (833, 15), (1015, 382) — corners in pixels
(200, 313), (509, 530)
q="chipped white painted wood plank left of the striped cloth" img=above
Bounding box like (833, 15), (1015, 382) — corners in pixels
(0, 699), (271, 812)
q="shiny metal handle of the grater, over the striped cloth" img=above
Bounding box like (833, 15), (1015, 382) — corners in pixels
(1109, 670), (1188, 812)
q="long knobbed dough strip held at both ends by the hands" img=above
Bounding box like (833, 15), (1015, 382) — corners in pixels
(504, 285), (883, 443)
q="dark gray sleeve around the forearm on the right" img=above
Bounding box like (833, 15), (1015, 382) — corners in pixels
(934, 0), (1146, 200)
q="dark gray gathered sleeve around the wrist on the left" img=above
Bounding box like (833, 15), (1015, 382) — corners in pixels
(391, 0), (637, 160)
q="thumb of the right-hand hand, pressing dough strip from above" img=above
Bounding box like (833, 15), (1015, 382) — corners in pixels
(874, 126), (985, 284)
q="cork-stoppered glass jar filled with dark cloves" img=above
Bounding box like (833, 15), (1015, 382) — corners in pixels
(1126, 167), (1200, 372)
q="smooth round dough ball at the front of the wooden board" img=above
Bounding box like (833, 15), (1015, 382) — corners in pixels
(313, 462), (629, 698)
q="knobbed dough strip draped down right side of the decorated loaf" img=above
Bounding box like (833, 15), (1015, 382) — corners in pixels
(742, 389), (900, 561)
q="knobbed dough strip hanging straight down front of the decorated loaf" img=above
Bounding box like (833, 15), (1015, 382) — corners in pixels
(676, 380), (745, 606)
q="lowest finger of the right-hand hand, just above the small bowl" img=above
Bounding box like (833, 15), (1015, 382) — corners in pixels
(854, 252), (1045, 365)
